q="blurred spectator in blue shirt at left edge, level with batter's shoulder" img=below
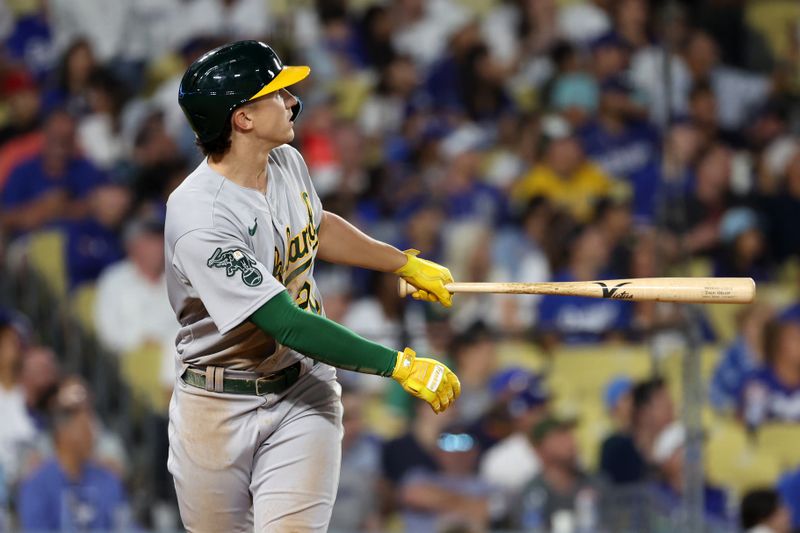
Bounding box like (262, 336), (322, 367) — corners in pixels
(0, 111), (104, 234)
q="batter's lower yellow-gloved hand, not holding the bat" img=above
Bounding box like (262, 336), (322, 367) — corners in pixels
(392, 348), (461, 413)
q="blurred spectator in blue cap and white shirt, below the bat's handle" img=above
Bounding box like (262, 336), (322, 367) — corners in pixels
(480, 368), (550, 494)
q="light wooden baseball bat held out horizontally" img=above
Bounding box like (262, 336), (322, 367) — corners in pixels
(399, 278), (756, 304)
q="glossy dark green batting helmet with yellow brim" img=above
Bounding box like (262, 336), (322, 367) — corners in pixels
(178, 41), (311, 142)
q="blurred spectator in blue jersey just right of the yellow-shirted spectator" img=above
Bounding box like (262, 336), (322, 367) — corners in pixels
(578, 76), (661, 221)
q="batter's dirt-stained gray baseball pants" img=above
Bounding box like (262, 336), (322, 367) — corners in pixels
(167, 363), (343, 533)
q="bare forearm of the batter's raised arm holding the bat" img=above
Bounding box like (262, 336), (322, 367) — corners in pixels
(317, 211), (408, 272)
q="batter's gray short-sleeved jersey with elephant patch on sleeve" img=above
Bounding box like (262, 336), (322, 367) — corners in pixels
(165, 141), (323, 375)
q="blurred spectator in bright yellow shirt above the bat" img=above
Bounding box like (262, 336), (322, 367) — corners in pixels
(511, 115), (612, 222)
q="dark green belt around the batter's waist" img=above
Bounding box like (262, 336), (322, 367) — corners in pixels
(181, 361), (302, 396)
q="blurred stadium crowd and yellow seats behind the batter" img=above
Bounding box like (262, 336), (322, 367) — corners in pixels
(0, 0), (800, 533)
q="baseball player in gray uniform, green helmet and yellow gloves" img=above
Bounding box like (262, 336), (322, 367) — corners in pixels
(165, 41), (460, 533)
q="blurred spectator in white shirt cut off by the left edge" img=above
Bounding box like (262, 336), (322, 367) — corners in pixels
(0, 309), (36, 485)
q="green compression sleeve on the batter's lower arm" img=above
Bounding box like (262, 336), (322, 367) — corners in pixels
(250, 291), (397, 376)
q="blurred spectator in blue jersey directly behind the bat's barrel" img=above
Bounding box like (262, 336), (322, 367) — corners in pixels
(539, 222), (632, 348)
